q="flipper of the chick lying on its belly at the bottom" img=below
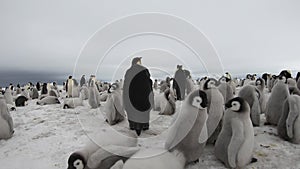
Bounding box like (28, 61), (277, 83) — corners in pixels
(87, 145), (139, 169)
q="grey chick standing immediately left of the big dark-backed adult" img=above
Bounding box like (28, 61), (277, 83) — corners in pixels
(104, 83), (126, 125)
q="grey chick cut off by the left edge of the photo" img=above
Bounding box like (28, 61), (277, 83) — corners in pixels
(0, 96), (14, 140)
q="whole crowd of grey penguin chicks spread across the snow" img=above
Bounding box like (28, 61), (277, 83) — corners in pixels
(0, 69), (300, 169)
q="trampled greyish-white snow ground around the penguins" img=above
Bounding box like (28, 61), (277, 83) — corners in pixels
(0, 89), (300, 169)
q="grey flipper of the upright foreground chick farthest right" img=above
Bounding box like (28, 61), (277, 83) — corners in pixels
(228, 118), (244, 168)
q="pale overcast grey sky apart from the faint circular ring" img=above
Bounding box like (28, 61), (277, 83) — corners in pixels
(0, 0), (300, 84)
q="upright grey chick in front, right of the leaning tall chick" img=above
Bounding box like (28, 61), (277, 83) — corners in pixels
(215, 97), (256, 168)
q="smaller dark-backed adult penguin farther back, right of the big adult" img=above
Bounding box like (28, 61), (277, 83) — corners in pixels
(173, 65), (186, 100)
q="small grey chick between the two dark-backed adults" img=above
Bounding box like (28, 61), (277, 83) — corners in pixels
(154, 88), (176, 115)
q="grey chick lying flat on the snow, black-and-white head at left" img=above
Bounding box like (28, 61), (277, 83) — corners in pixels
(68, 129), (139, 169)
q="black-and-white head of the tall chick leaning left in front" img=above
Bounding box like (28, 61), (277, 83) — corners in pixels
(188, 90), (208, 109)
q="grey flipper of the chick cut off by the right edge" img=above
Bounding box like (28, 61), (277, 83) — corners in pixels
(286, 96), (299, 138)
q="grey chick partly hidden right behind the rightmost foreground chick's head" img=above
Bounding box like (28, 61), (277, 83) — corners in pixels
(238, 85), (261, 126)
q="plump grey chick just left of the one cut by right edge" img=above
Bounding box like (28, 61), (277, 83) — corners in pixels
(265, 80), (290, 126)
